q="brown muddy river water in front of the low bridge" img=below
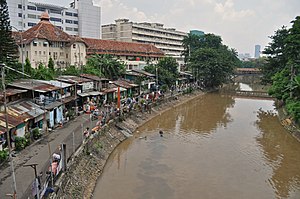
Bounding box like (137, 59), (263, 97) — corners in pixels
(94, 94), (300, 199)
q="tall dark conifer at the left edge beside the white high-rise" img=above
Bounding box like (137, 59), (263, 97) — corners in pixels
(0, 0), (17, 66)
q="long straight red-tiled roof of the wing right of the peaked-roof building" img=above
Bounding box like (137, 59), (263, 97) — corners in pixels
(83, 38), (164, 57)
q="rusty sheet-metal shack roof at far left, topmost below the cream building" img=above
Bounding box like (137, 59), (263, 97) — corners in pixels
(8, 79), (60, 93)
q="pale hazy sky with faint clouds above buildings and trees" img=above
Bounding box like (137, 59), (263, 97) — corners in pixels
(37, 0), (300, 55)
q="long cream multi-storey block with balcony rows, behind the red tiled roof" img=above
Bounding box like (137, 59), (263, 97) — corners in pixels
(102, 19), (187, 68)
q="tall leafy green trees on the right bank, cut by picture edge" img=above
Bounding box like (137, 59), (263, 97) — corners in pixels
(262, 16), (300, 122)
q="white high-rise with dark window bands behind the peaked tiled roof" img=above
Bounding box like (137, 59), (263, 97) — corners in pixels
(7, 0), (101, 39)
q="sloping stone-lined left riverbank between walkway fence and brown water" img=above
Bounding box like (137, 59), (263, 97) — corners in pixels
(52, 91), (203, 198)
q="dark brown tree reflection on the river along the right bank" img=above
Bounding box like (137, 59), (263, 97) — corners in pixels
(256, 111), (300, 198)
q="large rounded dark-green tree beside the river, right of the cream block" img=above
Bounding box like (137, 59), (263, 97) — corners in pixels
(183, 34), (240, 87)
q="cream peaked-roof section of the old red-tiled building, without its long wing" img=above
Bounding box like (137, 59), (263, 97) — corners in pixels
(13, 12), (86, 68)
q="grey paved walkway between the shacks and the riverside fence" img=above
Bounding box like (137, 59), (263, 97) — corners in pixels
(0, 114), (96, 199)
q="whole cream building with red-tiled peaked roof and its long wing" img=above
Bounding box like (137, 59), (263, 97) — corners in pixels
(13, 12), (165, 69)
